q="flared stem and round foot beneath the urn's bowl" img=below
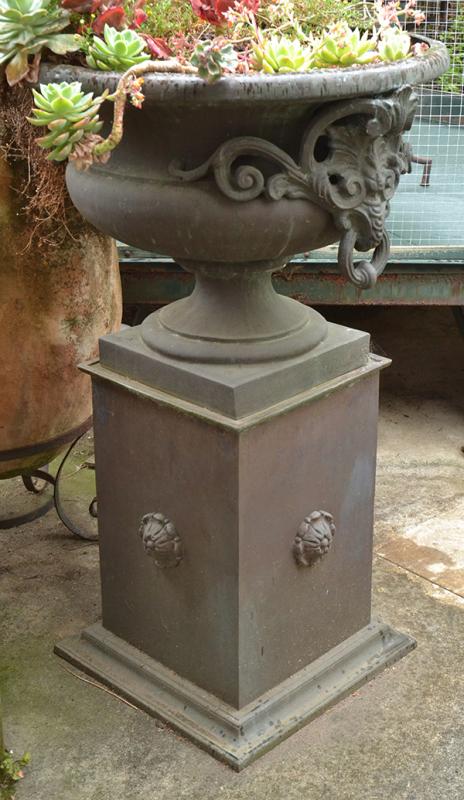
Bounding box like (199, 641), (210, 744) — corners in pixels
(142, 259), (327, 364)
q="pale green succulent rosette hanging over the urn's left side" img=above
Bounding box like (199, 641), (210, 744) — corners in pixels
(28, 81), (105, 161)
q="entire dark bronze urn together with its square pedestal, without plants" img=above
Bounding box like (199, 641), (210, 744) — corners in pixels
(48, 43), (447, 769)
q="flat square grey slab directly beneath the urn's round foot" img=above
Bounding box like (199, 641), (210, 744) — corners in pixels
(100, 323), (369, 419)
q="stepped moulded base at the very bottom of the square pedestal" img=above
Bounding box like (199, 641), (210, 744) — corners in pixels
(55, 622), (415, 771)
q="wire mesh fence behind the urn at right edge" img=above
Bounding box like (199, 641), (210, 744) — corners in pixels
(388, 0), (464, 250)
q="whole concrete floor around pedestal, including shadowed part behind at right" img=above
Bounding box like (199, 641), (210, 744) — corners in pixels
(0, 309), (464, 800)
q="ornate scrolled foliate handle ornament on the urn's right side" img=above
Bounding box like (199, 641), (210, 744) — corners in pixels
(170, 86), (417, 289)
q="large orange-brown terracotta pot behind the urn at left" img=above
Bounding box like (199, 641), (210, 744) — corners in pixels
(0, 160), (121, 478)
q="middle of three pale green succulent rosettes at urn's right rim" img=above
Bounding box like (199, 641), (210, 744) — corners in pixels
(314, 23), (378, 67)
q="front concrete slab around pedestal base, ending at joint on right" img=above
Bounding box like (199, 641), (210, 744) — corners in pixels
(2, 528), (464, 800)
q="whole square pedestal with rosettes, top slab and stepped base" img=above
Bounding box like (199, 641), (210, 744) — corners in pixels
(57, 325), (412, 769)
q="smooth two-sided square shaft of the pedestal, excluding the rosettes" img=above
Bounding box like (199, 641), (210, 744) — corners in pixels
(73, 359), (392, 709)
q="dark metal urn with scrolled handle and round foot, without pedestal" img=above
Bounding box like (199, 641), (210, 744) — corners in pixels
(41, 42), (448, 363)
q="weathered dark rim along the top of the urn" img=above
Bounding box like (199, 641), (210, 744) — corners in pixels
(40, 36), (449, 105)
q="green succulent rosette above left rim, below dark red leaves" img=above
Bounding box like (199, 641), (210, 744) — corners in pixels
(87, 25), (150, 72)
